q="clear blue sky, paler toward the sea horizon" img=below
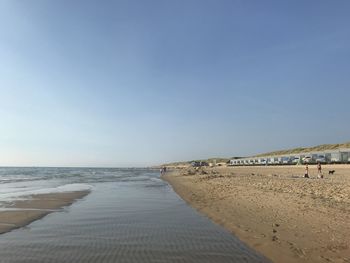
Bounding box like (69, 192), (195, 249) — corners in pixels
(0, 0), (350, 167)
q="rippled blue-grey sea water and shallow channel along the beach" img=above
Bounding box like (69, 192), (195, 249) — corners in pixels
(0, 168), (268, 263)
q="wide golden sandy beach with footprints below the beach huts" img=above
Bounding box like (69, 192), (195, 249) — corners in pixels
(164, 165), (350, 263)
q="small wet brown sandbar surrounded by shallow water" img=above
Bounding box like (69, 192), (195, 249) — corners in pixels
(0, 191), (89, 234)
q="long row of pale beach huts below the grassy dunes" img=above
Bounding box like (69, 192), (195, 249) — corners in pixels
(229, 148), (350, 166)
